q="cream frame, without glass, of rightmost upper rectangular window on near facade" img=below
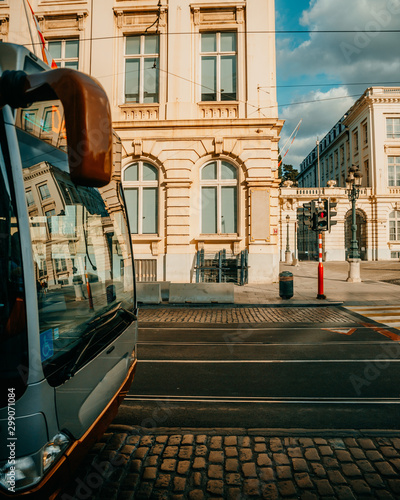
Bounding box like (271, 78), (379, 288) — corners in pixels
(199, 28), (239, 103)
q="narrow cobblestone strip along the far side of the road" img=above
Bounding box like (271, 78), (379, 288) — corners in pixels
(139, 306), (354, 324)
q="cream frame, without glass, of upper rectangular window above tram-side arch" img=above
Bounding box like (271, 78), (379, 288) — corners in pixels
(123, 32), (161, 105)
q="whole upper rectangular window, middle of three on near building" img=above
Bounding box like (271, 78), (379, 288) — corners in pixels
(125, 35), (159, 103)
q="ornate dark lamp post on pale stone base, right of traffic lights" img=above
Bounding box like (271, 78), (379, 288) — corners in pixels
(346, 165), (362, 283)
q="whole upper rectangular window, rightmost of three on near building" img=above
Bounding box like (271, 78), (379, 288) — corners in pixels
(201, 32), (237, 101)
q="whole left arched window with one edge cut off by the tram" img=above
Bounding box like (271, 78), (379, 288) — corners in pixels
(123, 161), (158, 234)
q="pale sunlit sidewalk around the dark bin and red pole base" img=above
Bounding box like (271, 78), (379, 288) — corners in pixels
(235, 261), (400, 305)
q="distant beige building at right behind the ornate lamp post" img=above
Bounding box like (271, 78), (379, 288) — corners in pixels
(294, 87), (400, 260)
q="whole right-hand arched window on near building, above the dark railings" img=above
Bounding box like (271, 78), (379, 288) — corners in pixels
(201, 160), (237, 234)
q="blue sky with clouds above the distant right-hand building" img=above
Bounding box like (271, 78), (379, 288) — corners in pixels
(275, 0), (400, 169)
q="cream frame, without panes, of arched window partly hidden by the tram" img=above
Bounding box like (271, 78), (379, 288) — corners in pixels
(121, 159), (160, 236)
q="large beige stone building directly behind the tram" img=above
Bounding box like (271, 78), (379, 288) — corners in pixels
(4, 0), (283, 283)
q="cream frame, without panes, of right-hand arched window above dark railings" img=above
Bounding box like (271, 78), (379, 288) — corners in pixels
(199, 159), (239, 236)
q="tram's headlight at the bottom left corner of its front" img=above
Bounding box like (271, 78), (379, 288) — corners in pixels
(0, 433), (70, 492)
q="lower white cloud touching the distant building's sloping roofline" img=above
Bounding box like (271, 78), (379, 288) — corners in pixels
(280, 87), (355, 168)
